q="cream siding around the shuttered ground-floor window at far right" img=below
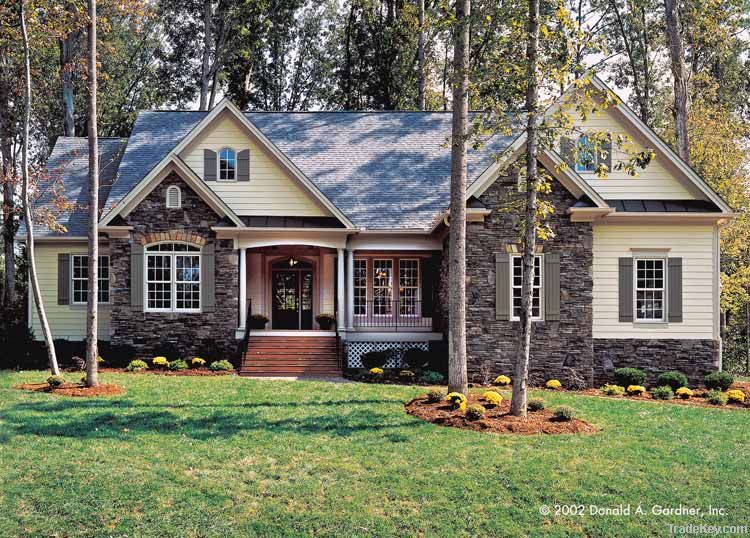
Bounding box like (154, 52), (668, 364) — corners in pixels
(593, 225), (716, 339)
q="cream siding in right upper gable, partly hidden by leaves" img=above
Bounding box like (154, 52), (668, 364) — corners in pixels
(572, 110), (696, 200)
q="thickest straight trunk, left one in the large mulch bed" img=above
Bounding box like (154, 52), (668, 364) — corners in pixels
(448, 0), (471, 394)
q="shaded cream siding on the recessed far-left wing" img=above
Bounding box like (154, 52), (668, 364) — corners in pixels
(31, 243), (112, 340)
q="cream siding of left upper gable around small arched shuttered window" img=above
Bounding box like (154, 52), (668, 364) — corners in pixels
(180, 114), (330, 217)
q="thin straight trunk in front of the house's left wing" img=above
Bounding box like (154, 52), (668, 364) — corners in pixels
(86, 0), (99, 387)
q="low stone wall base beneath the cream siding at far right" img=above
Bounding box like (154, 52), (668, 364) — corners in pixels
(594, 338), (720, 385)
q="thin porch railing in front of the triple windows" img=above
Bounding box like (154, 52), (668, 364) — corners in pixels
(354, 299), (432, 330)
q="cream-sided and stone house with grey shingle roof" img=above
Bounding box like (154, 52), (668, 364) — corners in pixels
(30, 77), (732, 385)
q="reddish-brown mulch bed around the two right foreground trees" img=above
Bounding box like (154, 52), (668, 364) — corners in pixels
(405, 394), (598, 435)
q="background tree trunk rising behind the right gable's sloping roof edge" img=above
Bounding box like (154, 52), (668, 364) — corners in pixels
(664, 0), (690, 163)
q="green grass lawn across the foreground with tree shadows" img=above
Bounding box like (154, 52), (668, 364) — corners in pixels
(0, 372), (750, 538)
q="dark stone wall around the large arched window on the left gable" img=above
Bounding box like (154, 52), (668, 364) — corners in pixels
(110, 173), (239, 359)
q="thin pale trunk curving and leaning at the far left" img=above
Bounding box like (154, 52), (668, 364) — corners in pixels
(19, 0), (60, 375)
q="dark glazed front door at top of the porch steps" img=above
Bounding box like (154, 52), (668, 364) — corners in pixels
(271, 258), (313, 330)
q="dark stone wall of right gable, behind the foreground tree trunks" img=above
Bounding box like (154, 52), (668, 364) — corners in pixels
(440, 170), (594, 385)
